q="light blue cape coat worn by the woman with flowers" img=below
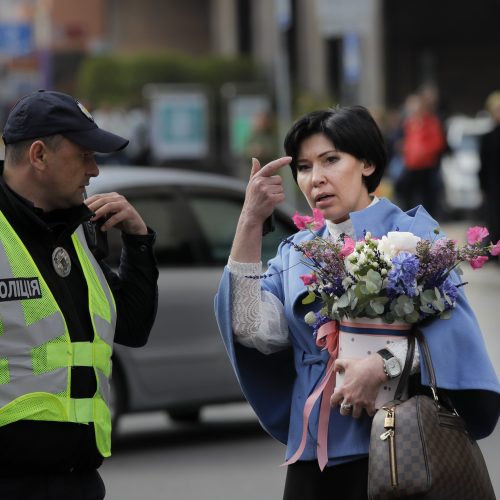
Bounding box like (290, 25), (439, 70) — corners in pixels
(215, 199), (500, 465)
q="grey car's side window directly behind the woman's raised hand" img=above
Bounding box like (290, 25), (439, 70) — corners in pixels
(189, 194), (294, 265)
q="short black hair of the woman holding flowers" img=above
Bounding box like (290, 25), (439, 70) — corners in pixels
(284, 106), (387, 193)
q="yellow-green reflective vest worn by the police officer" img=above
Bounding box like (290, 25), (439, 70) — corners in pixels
(0, 212), (116, 456)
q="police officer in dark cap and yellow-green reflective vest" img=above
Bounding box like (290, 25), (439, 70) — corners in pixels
(0, 91), (158, 500)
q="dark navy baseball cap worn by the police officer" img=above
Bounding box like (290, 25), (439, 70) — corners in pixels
(2, 90), (129, 153)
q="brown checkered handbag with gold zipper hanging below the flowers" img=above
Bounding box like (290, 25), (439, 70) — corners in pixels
(368, 330), (495, 500)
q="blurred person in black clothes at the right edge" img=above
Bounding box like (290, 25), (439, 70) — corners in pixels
(479, 90), (500, 260)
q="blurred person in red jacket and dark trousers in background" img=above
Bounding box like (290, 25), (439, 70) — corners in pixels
(396, 95), (446, 214)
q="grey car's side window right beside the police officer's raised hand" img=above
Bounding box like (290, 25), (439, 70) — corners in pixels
(107, 194), (199, 267)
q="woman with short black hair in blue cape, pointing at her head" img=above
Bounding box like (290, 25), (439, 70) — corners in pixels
(215, 106), (500, 500)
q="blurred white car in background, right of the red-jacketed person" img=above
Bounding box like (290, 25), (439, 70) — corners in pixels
(441, 115), (492, 215)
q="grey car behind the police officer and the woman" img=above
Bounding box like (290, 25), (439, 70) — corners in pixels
(87, 166), (295, 424)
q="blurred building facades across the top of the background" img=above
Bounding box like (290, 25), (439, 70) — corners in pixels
(0, 0), (500, 113)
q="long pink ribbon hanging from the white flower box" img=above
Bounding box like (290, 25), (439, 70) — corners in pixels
(283, 321), (338, 470)
